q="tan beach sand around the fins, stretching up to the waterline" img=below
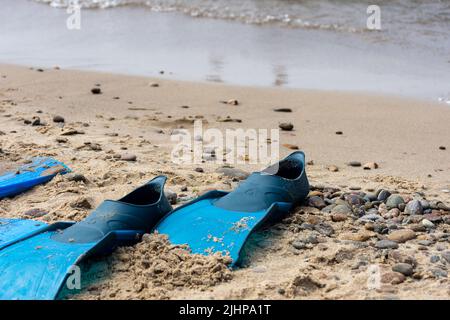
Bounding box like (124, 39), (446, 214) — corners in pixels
(0, 65), (450, 299)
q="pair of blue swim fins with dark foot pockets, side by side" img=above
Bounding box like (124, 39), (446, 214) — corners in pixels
(0, 151), (309, 299)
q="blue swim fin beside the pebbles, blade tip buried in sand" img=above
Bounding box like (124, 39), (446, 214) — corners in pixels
(155, 151), (309, 265)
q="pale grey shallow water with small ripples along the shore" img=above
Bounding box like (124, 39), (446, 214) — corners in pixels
(0, 0), (450, 101)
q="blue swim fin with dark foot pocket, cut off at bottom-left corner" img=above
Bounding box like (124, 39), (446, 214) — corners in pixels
(0, 176), (172, 300)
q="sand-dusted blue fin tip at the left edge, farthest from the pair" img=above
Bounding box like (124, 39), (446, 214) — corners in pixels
(0, 157), (70, 199)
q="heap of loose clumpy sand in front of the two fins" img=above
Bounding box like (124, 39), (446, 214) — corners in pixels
(71, 234), (232, 299)
